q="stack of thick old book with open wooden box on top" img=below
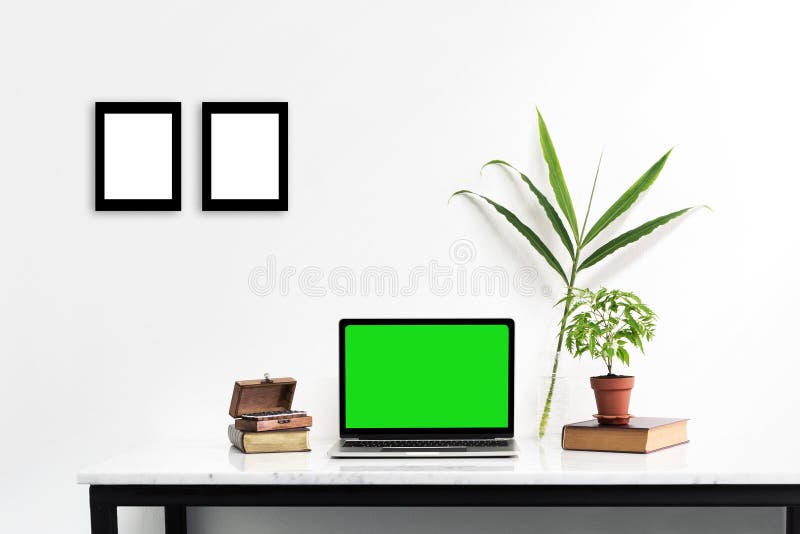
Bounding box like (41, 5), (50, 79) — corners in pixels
(228, 375), (312, 453)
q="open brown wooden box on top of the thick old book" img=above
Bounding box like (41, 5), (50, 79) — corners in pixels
(228, 377), (312, 432)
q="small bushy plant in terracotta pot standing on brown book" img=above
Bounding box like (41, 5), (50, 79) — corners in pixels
(561, 288), (657, 425)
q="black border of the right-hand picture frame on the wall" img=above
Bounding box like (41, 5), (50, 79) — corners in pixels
(202, 102), (289, 211)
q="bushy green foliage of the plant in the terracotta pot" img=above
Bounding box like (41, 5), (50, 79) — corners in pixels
(560, 288), (658, 375)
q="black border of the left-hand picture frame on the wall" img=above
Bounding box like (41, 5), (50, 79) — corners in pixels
(95, 102), (181, 211)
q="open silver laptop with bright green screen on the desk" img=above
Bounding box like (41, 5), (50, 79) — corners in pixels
(328, 319), (517, 458)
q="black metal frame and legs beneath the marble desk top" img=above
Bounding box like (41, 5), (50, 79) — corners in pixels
(89, 484), (800, 534)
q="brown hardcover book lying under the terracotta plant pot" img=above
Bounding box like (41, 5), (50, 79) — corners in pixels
(561, 417), (689, 453)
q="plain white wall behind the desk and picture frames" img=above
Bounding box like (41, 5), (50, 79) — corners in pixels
(0, 0), (800, 533)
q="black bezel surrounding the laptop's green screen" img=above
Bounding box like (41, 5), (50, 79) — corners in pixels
(339, 318), (514, 439)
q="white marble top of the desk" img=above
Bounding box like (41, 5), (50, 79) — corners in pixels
(78, 440), (800, 484)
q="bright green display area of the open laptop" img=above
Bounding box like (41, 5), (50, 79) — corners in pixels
(344, 324), (509, 428)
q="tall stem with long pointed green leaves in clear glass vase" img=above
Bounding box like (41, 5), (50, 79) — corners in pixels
(451, 109), (708, 438)
